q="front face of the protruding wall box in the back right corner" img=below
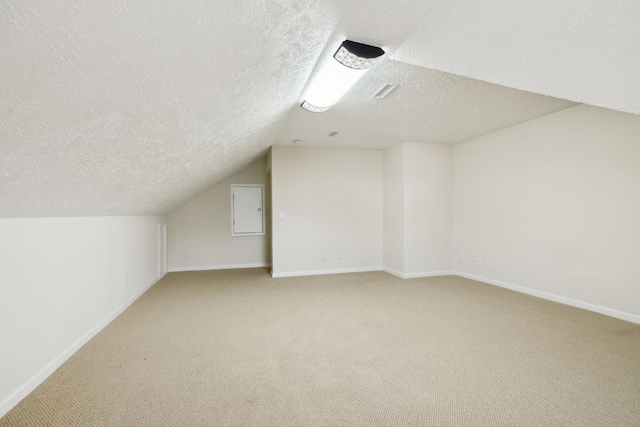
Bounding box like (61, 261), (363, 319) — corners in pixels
(403, 142), (453, 277)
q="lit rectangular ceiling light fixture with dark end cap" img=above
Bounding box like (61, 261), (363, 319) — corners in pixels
(301, 40), (384, 113)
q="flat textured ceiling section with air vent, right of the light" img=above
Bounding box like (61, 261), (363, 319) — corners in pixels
(276, 58), (576, 149)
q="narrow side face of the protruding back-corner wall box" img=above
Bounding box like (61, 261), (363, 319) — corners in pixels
(382, 144), (405, 276)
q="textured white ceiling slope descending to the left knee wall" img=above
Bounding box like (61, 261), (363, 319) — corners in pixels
(0, 0), (335, 217)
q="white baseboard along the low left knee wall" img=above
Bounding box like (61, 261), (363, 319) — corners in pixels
(0, 273), (166, 418)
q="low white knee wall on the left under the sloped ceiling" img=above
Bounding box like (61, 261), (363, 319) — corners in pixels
(0, 216), (165, 416)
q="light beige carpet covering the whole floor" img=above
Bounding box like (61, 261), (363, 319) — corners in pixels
(0, 269), (640, 426)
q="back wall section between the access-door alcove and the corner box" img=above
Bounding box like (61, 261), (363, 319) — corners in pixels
(271, 146), (382, 277)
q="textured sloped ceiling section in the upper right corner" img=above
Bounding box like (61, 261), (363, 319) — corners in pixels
(392, 0), (640, 114)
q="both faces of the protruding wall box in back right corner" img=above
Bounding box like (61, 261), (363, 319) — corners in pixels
(383, 142), (453, 277)
